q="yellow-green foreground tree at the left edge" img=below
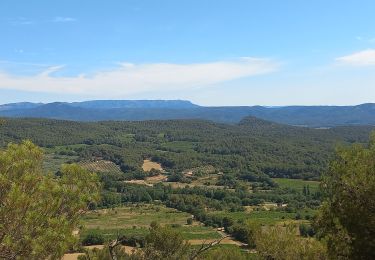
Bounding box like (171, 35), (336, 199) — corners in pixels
(0, 141), (99, 259)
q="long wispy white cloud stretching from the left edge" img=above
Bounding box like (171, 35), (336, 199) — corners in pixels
(0, 57), (279, 97)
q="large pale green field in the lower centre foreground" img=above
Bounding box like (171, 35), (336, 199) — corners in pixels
(81, 204), (221, 240)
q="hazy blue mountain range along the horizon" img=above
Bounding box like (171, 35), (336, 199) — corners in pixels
(0, 100), (375, 127)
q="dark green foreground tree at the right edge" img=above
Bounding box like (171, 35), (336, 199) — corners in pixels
(316, 133), (375, 259)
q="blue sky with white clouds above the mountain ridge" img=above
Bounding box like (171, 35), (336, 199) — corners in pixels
(0, 0), (375, 106)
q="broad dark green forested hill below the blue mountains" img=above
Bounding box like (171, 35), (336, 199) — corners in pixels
(0, 117), (375, 179)
